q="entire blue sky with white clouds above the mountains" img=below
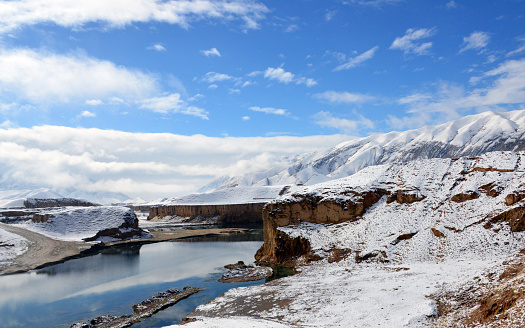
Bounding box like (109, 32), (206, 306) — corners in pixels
(0, 0), (525, 199)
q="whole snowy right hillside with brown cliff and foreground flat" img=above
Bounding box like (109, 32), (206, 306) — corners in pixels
(188, 151), (525, 327)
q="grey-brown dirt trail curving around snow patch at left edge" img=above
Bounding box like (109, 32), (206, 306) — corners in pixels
(0, 223), (93, 274)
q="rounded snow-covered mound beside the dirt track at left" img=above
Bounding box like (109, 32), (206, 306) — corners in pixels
(14, 206), (136, 241)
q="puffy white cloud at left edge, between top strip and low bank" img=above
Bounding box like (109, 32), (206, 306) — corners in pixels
(0, 49), (158, 104)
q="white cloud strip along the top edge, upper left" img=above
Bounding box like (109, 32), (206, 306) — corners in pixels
(0, 0), (269, 33)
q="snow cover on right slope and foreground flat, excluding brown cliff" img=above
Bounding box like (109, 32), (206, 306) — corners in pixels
(179, 152), (525, 328)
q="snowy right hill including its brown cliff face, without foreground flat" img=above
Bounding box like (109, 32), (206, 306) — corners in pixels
(256, 152), (525, 266)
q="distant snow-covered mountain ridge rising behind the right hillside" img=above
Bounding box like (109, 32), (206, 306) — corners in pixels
(210, 110), (525, 189)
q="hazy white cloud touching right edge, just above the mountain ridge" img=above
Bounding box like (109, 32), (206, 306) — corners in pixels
(390, 59), (525, 128)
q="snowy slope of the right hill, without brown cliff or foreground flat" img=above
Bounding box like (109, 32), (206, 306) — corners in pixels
(275, 152), (525, 263)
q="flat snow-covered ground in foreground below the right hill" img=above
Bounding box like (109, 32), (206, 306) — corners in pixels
(184, 259), (501, 328)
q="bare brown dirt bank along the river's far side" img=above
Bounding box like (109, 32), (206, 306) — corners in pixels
(0, 223), (252, 275)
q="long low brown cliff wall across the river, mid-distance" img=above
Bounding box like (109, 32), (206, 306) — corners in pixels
(148, 203), (264, 223)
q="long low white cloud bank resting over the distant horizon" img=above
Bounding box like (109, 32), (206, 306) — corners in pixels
(0, 124), (348, 199)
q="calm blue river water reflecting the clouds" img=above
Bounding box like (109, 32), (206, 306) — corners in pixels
(0, 233), (264, 328)
